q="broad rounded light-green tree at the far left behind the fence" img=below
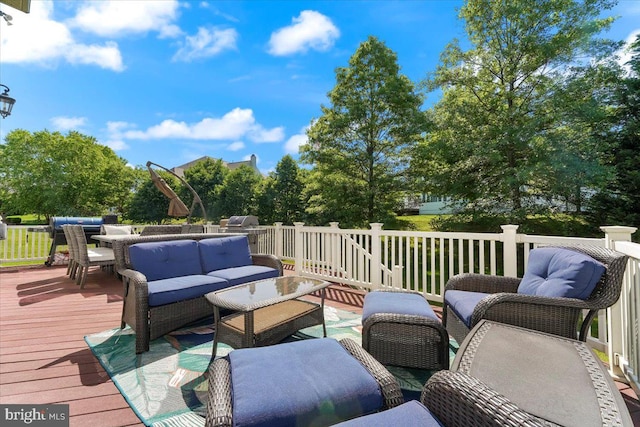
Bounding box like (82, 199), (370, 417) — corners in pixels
(0, 130), (134, 218)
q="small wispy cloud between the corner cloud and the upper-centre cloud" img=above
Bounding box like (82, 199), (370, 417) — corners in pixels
(173, 27), (238, 62)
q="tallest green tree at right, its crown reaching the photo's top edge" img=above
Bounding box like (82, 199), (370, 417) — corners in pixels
(417, 0), (615, 220)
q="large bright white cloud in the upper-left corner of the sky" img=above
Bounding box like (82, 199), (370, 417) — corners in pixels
(0, 1), (124, 71)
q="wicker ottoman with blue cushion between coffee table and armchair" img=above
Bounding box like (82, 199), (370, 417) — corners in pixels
(362, 290), (449, 370)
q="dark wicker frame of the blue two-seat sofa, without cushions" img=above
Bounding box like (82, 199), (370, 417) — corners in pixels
(113, 233), (283, 353)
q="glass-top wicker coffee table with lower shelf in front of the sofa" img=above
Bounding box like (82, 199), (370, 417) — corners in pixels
(206, 276), (330, 359)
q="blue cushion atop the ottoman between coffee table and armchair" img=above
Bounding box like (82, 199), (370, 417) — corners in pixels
(362, 291), (438, 322)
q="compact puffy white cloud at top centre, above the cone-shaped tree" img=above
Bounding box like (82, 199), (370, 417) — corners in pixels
(269, 10), (340, 56)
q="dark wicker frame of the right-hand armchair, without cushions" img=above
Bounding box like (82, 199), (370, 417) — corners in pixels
(443, 246), (627, 343)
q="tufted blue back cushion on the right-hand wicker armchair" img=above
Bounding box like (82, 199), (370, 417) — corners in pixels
(518, 248), (605, 300)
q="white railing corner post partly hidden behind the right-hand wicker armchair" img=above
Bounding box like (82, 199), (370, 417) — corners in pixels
(600, 225), (638, 378)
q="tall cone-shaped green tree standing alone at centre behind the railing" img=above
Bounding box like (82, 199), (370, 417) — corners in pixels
(301, 37), (427, 226)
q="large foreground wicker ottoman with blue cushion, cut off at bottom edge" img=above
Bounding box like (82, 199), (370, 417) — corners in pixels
(205, 338), (403, 427)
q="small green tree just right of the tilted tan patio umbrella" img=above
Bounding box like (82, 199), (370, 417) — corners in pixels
(180, 158), (229, 222)
